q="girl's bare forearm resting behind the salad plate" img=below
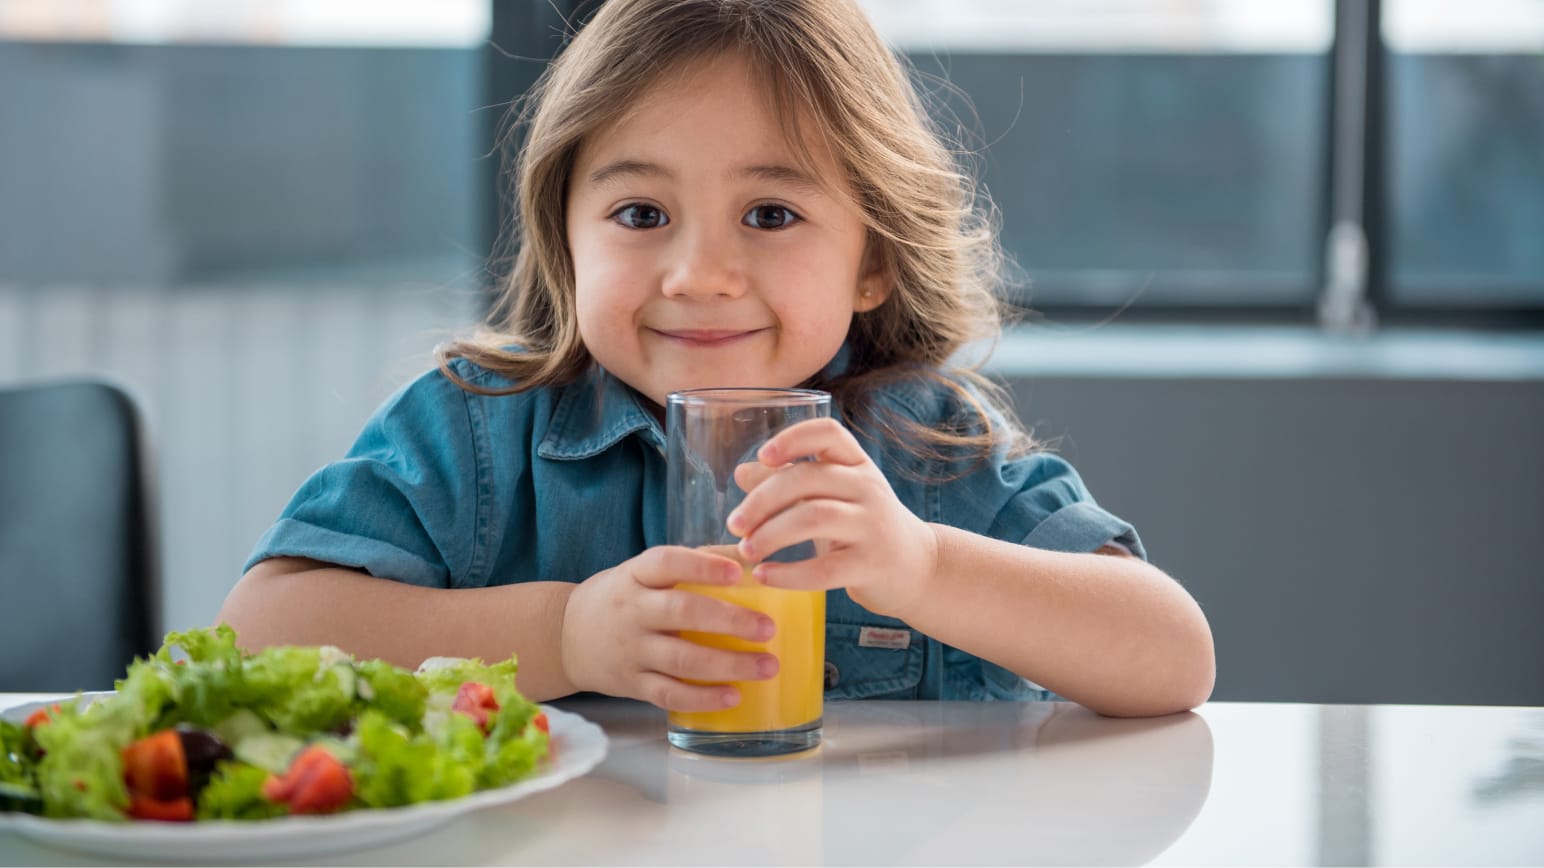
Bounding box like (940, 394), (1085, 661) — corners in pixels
(219, 558), (574, 701)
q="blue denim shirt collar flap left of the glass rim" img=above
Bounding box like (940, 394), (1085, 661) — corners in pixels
(536, 364), (665, 460)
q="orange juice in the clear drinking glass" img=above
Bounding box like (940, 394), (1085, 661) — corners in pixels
(670, 567), (826, 732)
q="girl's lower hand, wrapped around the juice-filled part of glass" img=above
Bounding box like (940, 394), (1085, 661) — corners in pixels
(562, 545), (778, 712)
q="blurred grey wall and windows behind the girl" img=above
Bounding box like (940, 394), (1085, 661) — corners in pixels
(0, 0), (1544, 704)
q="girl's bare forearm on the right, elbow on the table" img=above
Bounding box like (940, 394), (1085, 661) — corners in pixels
(900, 525), (1215, 717)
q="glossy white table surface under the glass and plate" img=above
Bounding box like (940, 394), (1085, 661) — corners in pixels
(0, 693), (1544, 865)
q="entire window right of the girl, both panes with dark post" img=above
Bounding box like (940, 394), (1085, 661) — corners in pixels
(863, 0), (1544, 324)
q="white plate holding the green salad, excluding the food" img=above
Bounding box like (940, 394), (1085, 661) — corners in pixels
(0, 703), (607, 862)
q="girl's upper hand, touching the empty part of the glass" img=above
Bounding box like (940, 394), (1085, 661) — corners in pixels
(729, 419), (937, 616)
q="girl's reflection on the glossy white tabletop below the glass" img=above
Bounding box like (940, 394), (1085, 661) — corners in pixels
(562, 703), (1212, 865)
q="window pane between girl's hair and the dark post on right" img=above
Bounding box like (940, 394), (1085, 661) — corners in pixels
(866, 0), (1332, 309)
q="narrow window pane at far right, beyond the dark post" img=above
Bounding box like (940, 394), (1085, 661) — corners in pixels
(1382, 0), (1544, 307)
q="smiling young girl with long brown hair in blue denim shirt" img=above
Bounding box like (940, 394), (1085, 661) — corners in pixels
(221, 0), (1214, 715)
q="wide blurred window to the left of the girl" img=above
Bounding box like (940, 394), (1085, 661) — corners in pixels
(0, 0), (491, 286)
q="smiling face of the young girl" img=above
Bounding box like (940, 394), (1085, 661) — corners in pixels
(567, 56), (888, 405)
